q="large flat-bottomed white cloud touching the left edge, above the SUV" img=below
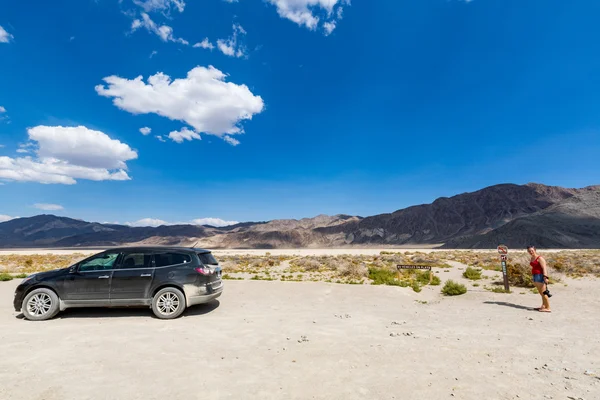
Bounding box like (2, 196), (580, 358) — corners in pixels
(0, 126), (137, 185)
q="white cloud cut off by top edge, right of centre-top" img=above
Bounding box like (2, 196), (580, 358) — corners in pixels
(267, 0), (350, 35)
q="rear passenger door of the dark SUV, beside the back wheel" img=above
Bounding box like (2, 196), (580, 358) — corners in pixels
(110, 250), (154, 305)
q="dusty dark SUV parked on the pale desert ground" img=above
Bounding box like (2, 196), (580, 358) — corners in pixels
(14, 247), (223, 321)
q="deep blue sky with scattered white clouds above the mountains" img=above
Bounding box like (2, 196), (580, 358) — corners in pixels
(0, 0), (600, 223)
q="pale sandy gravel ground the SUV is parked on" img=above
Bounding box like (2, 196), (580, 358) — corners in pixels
(0, 268), (600, 400)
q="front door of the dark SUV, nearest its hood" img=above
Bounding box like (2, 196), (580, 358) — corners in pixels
(63, 251), (120, 306)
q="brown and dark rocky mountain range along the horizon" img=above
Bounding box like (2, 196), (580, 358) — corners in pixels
(0, 183), (600, 249)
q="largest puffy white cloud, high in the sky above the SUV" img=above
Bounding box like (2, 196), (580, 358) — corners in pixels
(96, 66), (264, 145)
